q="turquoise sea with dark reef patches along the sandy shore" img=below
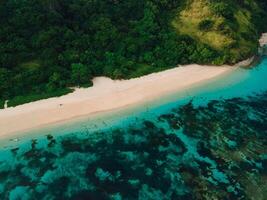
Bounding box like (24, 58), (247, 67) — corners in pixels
(0, 58), (267, 200)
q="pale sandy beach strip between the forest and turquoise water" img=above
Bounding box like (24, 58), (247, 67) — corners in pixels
(0, 60), (250, 138)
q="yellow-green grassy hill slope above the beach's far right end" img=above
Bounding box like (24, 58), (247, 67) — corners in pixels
(172, 0), (266, 64)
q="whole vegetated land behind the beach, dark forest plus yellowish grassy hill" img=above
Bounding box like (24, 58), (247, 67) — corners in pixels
(0, 0), (267, 105)
